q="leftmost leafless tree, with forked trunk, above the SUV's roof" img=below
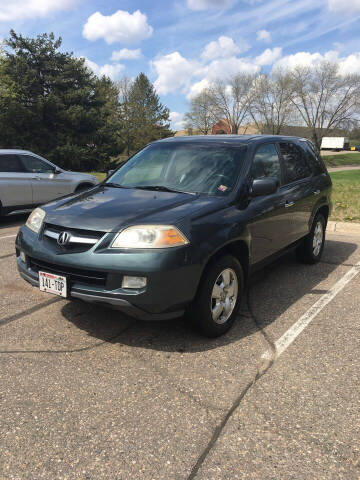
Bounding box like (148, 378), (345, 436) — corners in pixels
(209, 73), (254, 134)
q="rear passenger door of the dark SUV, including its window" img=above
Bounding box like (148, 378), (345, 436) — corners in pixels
(279, 141), (315, 243)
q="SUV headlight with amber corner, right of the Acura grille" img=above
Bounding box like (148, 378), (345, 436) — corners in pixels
(111, 225), (189, 248)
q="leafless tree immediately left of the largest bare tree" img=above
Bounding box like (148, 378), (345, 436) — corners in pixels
(249, 71), (294, 135)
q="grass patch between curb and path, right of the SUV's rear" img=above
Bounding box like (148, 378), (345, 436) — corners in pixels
(330, 170), (360, 222)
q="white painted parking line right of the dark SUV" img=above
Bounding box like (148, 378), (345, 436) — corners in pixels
(261, 262), (360, 360)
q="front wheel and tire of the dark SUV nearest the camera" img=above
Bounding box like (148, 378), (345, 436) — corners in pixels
(188, 255), (244, 337)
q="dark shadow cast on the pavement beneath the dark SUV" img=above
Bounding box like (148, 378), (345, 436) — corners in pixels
(62, 240), (358, 352)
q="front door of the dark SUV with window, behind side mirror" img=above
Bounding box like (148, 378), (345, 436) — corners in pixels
(247, 143), (293, 263)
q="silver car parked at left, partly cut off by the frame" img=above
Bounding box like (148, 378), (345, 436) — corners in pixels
(0, 150), (98, 216)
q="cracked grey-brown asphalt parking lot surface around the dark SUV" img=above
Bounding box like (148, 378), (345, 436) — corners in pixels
(0, 217), (360, 480)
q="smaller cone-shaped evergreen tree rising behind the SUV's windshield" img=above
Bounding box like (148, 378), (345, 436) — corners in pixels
(123, 73), (173, 154)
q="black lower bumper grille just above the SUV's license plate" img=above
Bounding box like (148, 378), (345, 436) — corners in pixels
(27, 257), (107, 285)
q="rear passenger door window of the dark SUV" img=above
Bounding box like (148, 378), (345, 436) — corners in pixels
(280, 142), (312, 183)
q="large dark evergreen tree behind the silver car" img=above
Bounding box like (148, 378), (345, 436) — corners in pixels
(0, 30), (121, 170)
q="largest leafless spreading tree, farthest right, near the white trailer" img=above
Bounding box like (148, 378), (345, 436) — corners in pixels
(290, 61), (360, 149)
